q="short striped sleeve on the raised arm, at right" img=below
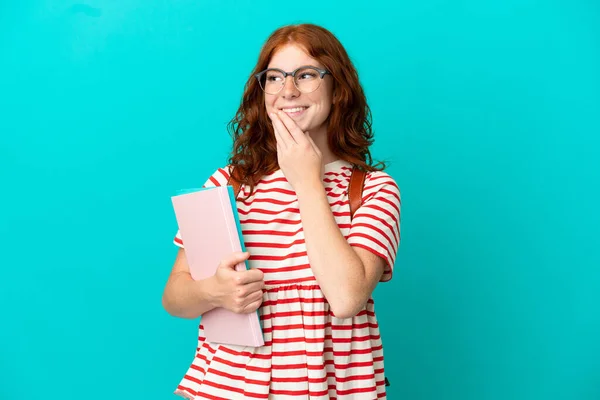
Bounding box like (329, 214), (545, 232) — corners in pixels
(347, 171), (401, 282)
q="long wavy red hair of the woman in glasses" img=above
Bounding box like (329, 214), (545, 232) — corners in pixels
(228, 24), (385, 193)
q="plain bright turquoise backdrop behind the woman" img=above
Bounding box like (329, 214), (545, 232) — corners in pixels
(0, 0), (600, 400)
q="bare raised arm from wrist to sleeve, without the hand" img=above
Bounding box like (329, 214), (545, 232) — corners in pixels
(296, 180), (385, 318)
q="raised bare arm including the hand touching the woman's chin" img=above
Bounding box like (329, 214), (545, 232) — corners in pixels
(270, 112), (385, 318)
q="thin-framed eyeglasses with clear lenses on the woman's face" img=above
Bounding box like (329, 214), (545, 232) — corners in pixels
(254, 65), (331, 94)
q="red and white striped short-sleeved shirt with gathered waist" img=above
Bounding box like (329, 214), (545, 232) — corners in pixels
(174, 160), (401, 400)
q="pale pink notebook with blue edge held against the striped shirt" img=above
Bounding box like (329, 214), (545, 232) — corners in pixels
(171, 186), (264, 346)
